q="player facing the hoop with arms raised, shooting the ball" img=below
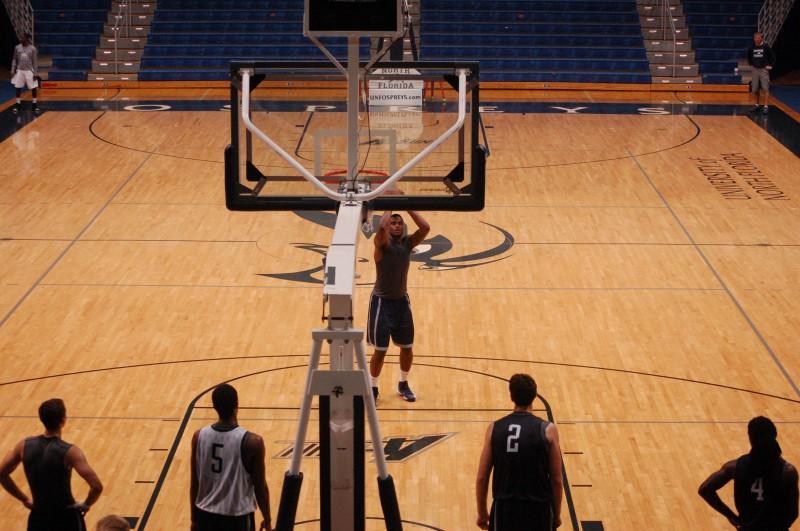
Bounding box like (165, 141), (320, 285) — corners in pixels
(367, 205), (431, 402)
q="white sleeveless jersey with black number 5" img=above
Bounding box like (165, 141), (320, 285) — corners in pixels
(195, 426), (256, 516)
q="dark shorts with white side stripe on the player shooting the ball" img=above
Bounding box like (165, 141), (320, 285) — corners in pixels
(367, 293), (414, 350)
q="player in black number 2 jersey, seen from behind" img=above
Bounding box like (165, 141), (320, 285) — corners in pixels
(475, 374), (564, 531)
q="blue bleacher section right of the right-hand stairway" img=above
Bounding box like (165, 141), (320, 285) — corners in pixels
(683, 0), (762, 85)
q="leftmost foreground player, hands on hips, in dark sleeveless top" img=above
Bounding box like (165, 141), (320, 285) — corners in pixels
(0, 398), (103, 531)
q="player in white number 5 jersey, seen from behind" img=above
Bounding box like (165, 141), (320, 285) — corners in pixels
(190, 384), (272, 531)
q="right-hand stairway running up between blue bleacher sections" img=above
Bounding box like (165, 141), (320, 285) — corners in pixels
(636, 0), (703, 84)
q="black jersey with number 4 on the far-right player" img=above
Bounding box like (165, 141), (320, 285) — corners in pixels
(733, 454), (791, 531)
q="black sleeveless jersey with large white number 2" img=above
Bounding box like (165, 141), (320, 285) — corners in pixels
(492, 412), (553, 503)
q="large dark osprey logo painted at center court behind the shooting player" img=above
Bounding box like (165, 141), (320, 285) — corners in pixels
(259, 211), (514, 284)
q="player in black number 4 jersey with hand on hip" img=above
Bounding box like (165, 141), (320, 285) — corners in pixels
(699, 417), (798, 531)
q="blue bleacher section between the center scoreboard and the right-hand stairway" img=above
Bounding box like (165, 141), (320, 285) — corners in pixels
(420, 0), (651, 83)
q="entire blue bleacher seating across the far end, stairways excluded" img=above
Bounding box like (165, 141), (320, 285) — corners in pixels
(28, 0), (761, 84)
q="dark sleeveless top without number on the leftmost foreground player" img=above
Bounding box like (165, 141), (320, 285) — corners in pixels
(22, 435), (75, 511)
